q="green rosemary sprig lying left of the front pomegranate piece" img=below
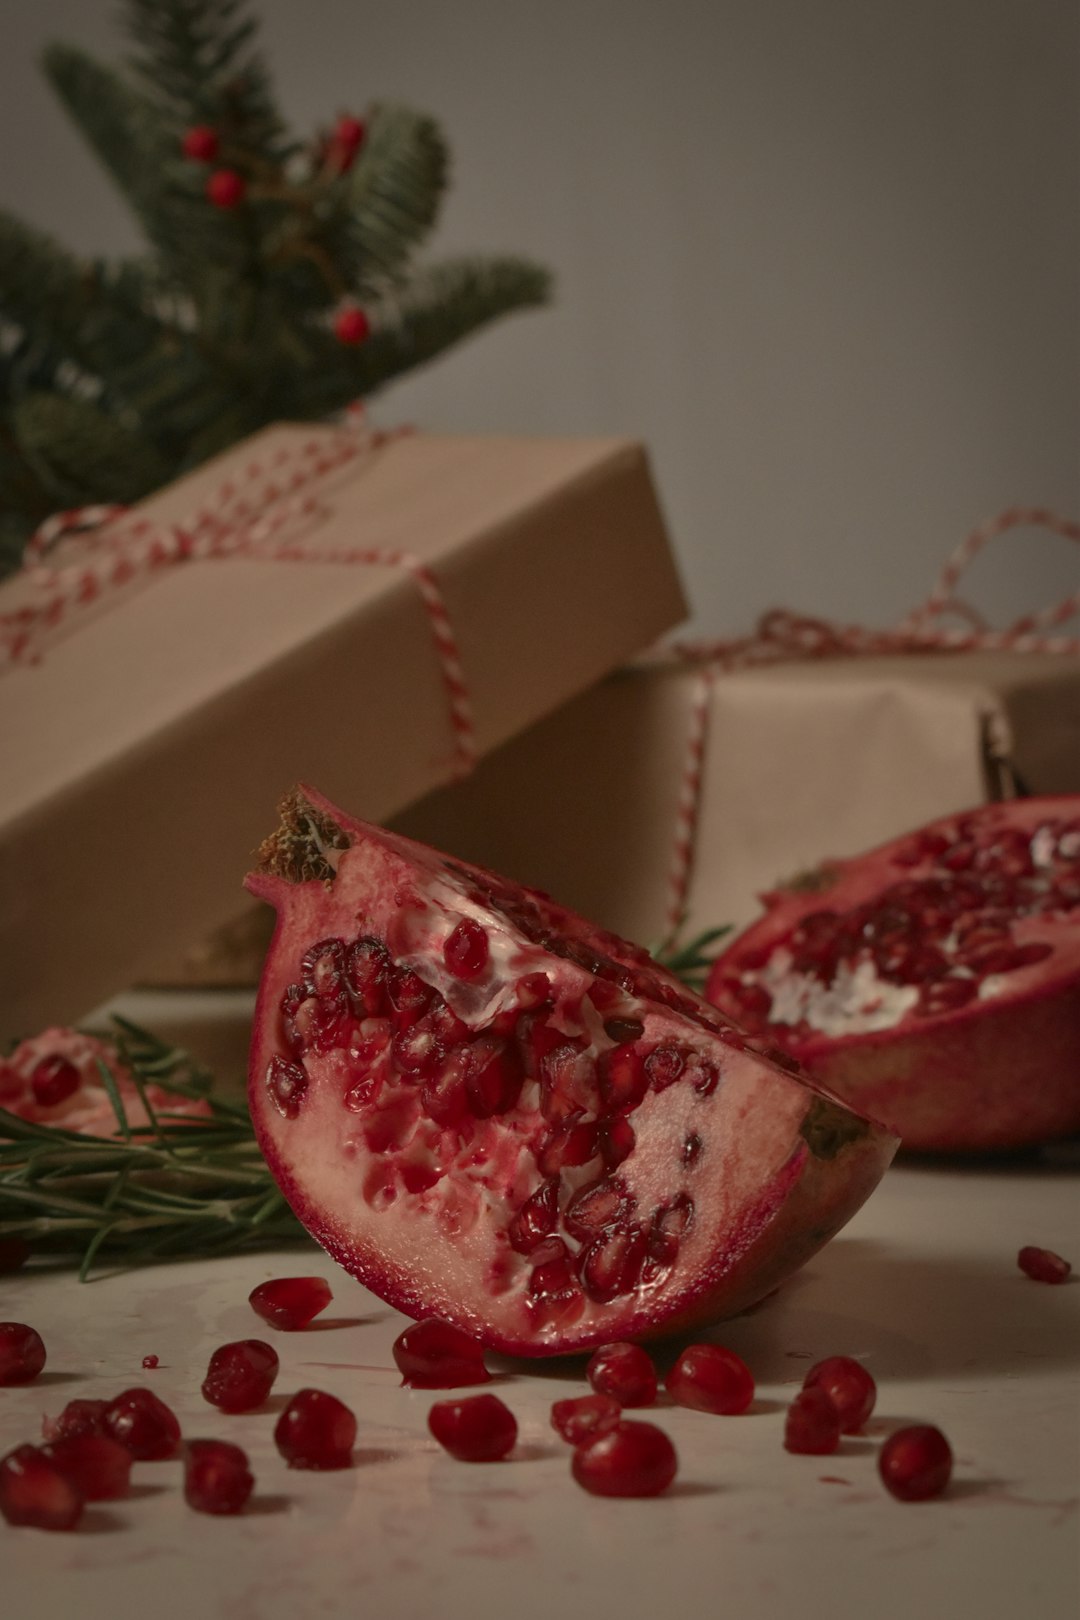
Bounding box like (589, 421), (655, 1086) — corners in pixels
(0, 1017), (306, 1281)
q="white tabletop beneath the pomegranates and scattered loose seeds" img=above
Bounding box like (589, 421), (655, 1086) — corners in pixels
(0, 1150), (1080, 1620)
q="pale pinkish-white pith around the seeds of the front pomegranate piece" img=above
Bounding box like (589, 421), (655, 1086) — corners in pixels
(251, 810), (891, 1349)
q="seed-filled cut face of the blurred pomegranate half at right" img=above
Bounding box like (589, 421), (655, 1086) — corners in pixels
(712, 816), (1080, 1032)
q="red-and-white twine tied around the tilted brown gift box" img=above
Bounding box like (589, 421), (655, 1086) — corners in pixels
(0, 407), (478, 778)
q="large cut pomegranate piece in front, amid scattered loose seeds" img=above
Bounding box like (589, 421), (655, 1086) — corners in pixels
(248, 791), (895, 1356)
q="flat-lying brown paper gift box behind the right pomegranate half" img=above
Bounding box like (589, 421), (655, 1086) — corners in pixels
(395, 653), (1080, 943)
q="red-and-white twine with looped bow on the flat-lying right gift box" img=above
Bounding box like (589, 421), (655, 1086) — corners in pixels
(664, 507), (1080, 936)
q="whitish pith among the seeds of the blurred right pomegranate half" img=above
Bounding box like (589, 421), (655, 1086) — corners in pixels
(738, 818), (1080, 1035)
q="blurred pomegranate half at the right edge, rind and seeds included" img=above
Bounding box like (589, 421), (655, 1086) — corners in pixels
(708, 795), (1080, 1152)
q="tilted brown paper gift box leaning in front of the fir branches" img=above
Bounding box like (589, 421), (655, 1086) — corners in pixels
(0, 426), (685, 1038)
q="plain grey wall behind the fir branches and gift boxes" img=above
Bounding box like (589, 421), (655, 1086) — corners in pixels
(0, 0), (1080, 633)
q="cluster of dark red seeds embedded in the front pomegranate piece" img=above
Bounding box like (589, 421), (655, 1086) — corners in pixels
(264, 865), (746, 1327)
